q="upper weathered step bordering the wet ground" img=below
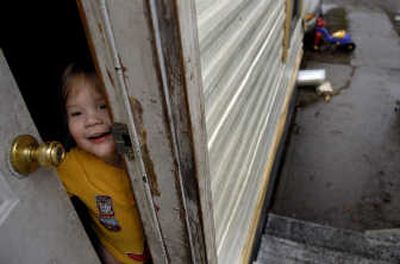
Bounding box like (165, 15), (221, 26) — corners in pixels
(264, 214), (400, 263)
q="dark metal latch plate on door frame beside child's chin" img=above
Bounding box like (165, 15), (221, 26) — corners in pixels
(111, 123), (135, 160)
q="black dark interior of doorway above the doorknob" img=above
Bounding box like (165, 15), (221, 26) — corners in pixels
(0, 0), (90, 141)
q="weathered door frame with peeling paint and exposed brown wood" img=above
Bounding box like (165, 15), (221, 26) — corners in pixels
(77, 0), (217, 263)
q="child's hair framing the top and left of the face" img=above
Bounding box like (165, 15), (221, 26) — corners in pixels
(59, 61), (101, 151)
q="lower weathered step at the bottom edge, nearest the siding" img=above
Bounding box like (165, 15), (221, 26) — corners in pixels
(254, 235), (393, 264)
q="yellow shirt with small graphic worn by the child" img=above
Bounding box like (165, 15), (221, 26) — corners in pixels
(58, 148), (144, 264)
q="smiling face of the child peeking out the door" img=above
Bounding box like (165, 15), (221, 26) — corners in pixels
(66, 76), (116, 163)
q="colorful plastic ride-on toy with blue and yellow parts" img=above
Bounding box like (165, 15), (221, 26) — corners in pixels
(313, 17), (356, 52)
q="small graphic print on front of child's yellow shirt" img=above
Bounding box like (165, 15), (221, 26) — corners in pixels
(96, 195), (121, 232)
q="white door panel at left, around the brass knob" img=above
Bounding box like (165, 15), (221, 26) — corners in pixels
(0, 50), (99, 264)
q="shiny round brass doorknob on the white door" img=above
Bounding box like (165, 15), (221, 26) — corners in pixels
(10, 135), (65, 175)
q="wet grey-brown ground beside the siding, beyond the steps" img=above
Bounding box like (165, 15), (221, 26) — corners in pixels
(272, 0), (400, 230)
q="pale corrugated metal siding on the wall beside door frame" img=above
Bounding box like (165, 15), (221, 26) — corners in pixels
(196, 0), (301, 263)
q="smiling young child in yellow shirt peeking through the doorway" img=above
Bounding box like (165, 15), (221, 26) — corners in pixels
(58, 65), (147, 263)
